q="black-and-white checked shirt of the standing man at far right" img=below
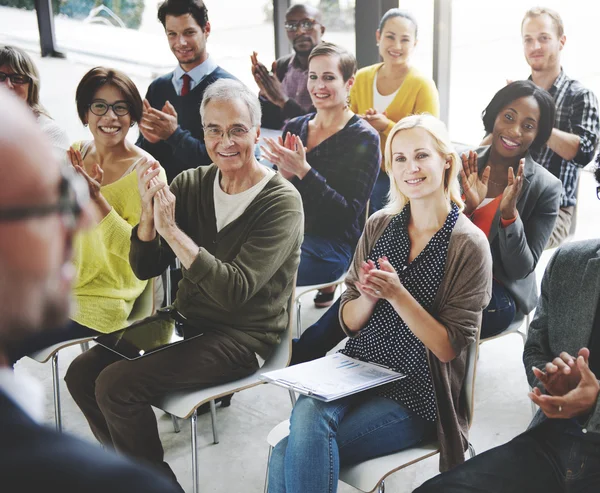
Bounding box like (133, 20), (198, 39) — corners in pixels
(529, 69), (599, 208)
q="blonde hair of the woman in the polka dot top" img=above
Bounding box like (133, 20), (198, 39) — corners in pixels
(384, 114), (464, 214)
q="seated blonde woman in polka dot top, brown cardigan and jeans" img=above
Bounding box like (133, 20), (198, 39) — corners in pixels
(269, 115), (492, 493)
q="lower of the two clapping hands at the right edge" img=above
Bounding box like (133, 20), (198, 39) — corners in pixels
(529, 354), (600, 419)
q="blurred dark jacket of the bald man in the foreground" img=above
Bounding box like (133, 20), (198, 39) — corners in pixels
(0, 391), (183, 493)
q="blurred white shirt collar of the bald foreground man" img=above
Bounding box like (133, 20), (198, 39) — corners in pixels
(0, 368), (45, 423)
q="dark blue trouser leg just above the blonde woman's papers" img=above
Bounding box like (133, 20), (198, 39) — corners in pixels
(290, 298), (346, 365)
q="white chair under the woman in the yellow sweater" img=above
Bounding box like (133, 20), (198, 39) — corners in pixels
(27, 280), (154, 433)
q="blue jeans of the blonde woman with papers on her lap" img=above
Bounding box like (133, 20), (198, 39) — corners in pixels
(269, 392), (435, 493)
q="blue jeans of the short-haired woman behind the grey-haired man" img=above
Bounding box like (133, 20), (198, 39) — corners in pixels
(296, 235), (352, 286)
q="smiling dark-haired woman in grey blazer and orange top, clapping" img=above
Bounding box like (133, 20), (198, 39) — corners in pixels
(461, 80), (562, 339)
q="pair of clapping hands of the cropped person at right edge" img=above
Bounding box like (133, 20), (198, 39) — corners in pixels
(529, 348), (600, 419)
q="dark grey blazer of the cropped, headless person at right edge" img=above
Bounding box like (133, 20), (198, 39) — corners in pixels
(523, 240), (600, 437)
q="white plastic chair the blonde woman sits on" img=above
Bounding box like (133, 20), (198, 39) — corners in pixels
(265, 340), (479, 493)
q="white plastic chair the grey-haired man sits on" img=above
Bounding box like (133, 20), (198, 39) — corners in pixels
(156, 290), (295, 493)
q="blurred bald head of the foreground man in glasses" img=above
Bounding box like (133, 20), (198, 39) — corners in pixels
(0, 87), (73, 358)
